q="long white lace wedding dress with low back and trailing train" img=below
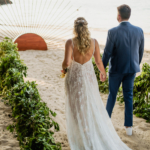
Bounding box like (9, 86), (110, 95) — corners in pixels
(65, 39), (131, 150)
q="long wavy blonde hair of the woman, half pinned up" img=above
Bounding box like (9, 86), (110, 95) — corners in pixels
(73, 17), (91, 55)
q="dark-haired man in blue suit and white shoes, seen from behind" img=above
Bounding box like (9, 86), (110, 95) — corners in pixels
(100, 5), (144, 135)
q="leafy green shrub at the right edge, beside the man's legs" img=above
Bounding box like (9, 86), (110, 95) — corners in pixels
(117, 63), (150, 122)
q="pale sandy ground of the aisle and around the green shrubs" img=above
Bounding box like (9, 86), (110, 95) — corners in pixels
(0, 49), (150, 150)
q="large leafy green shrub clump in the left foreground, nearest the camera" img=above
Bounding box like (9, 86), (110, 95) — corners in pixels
(5, 81), (61, 150)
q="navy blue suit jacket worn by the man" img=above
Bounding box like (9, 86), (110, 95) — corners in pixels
(102, 22), (144, 74)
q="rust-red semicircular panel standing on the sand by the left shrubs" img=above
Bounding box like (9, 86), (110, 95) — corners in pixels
(14, 33), (47, 51)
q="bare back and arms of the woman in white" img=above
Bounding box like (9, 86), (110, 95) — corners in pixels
(62, 38), (106, 81)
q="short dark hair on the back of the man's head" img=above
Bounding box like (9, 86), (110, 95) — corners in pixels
(117, 4), (131, 19)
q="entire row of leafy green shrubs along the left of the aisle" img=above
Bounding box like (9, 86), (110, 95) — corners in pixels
(0, 37), (61, 150)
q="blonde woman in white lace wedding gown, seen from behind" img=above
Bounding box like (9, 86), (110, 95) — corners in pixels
(62, 17), (131, 150)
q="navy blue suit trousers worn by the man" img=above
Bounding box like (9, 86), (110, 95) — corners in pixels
(106, 73), (136, 127)
